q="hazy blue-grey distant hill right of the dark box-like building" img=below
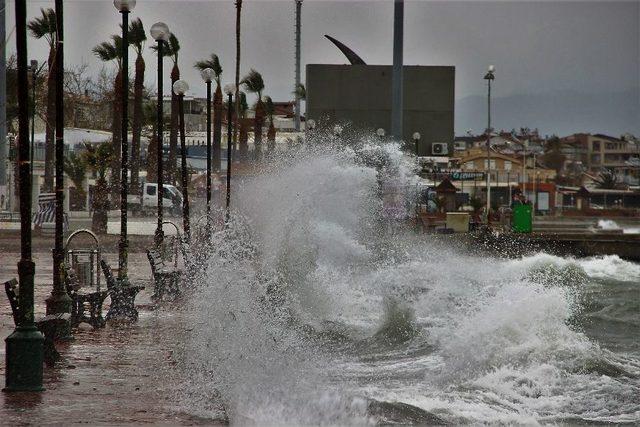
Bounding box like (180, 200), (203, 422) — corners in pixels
(455, 88), (640, 136)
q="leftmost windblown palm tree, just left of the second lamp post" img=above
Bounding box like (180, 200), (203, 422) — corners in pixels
(27, 9), (56, 192)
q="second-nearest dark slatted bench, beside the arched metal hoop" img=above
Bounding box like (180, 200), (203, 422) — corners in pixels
(63, 264), (109, 329)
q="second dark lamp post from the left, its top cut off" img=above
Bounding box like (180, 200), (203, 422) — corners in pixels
(46, 0), (71, 322)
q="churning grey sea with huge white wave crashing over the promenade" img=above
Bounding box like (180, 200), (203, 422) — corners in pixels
(172, 133), (640, 425)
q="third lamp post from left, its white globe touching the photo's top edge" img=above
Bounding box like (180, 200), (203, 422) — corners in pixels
(113, 0), (136, 281)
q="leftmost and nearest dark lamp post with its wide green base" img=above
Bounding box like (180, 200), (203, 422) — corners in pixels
(4, 0), (44, 392)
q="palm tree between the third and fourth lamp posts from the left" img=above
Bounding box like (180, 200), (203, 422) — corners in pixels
(129, 18), (147, 194)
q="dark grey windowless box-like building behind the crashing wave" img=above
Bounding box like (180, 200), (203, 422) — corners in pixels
(306, 64), (455, 156)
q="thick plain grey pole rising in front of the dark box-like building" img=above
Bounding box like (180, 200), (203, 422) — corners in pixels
(391, 0), (404, 140)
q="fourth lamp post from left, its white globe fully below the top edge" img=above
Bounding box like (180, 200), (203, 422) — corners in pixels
(150, 22), (171, 249)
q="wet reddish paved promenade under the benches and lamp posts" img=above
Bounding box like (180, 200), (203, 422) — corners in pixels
(0, 251), (219, 425)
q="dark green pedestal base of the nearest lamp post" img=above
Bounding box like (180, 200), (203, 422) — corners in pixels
(2, 325), (44, 392)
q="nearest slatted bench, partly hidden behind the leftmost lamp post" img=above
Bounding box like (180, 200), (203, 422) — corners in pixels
(4, 279), (71, 364)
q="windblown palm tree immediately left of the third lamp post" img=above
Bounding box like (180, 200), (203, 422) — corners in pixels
(93, 35), (122, 208)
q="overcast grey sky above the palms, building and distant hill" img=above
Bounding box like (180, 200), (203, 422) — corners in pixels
(2, 0), (640, 105)
